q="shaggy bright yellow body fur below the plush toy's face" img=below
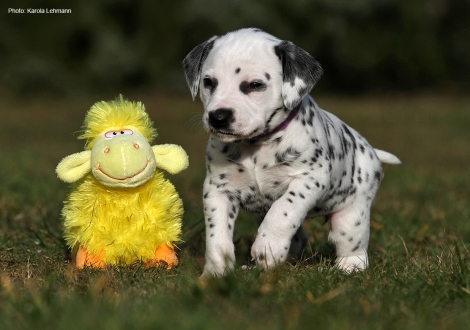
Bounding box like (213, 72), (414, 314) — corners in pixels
(62, 169), (183, 264)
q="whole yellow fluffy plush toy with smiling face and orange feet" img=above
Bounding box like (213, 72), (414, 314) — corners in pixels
(56, 96), (188, 268)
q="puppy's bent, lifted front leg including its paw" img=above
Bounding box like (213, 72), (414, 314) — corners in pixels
(251, 179), (323, 269)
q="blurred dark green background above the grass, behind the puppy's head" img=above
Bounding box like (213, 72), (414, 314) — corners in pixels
(0, 0), (470, 97)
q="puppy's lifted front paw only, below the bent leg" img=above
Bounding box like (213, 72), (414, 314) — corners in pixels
(251, 235), (290, 269)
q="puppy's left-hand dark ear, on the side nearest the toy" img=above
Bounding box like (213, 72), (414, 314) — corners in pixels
(183, 36), (218, 100)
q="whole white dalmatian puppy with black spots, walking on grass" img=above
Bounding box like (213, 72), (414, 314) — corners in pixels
(183, 29), (400, 276)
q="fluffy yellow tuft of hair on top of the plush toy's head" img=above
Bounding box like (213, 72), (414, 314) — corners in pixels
(78, 95), (157, 150)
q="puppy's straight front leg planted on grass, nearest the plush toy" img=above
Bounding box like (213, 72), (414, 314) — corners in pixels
(202, 179), (239, 277)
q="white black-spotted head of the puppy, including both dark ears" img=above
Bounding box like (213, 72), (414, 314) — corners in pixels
(183, 29), (322, 142)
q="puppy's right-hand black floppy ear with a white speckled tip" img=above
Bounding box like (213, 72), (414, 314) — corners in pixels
(274, 41), (323, 109)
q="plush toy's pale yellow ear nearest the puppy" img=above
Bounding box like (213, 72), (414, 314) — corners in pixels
(152, 144), (189, 174)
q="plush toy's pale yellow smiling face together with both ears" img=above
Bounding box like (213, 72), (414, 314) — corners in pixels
(56, 126), (188, 188)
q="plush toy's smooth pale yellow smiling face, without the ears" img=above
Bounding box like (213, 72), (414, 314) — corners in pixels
(91, 127), (156, 188)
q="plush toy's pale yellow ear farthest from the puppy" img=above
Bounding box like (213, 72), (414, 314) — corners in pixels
(55, 150), (91, 183)
